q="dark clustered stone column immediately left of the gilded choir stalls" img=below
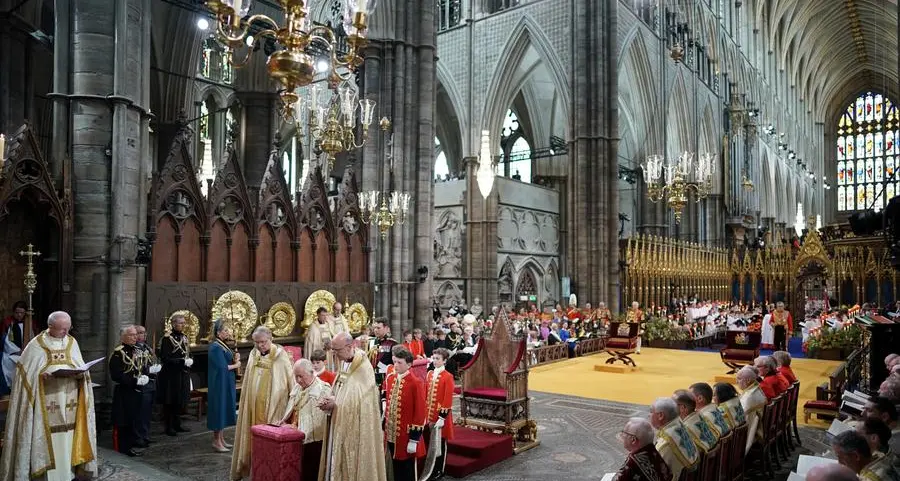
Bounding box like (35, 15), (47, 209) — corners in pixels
(566, 0), (619, 311)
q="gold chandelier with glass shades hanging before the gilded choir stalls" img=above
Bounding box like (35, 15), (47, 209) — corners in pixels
(641, 152), (716, 224)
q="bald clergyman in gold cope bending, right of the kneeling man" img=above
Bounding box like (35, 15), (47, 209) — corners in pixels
(318, 332), (386, 481)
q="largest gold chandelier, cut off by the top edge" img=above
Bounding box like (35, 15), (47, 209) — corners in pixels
(206, 0), (375, 109)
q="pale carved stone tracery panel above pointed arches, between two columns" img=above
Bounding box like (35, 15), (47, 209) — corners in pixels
(497, 207), (559, 255)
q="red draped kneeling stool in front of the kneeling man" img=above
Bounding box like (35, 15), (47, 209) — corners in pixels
(250, 424), (306, 481)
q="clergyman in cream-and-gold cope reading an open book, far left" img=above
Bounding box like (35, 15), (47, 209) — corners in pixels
(0, 312), (97, 481)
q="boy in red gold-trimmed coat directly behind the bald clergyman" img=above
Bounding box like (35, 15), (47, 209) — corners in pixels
(382, 346), (426, 481)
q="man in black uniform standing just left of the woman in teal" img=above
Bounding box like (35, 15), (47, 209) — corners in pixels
(156, 331), (191, 436)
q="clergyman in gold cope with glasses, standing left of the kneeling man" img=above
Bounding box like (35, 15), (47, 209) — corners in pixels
(231, 326), (293, 480)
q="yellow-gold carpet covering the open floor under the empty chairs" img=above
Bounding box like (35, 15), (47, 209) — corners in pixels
(528, 348), (840, 425)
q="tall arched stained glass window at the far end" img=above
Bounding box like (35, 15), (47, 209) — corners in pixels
(837, 92), (900, 212)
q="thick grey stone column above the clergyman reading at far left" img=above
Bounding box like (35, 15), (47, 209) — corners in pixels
(62, 0), (151, 376)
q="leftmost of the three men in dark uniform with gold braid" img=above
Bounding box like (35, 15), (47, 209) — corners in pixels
(109, 326), (150, 456)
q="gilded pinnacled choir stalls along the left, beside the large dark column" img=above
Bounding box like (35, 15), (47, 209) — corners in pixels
(621, 234), (732, 306)
